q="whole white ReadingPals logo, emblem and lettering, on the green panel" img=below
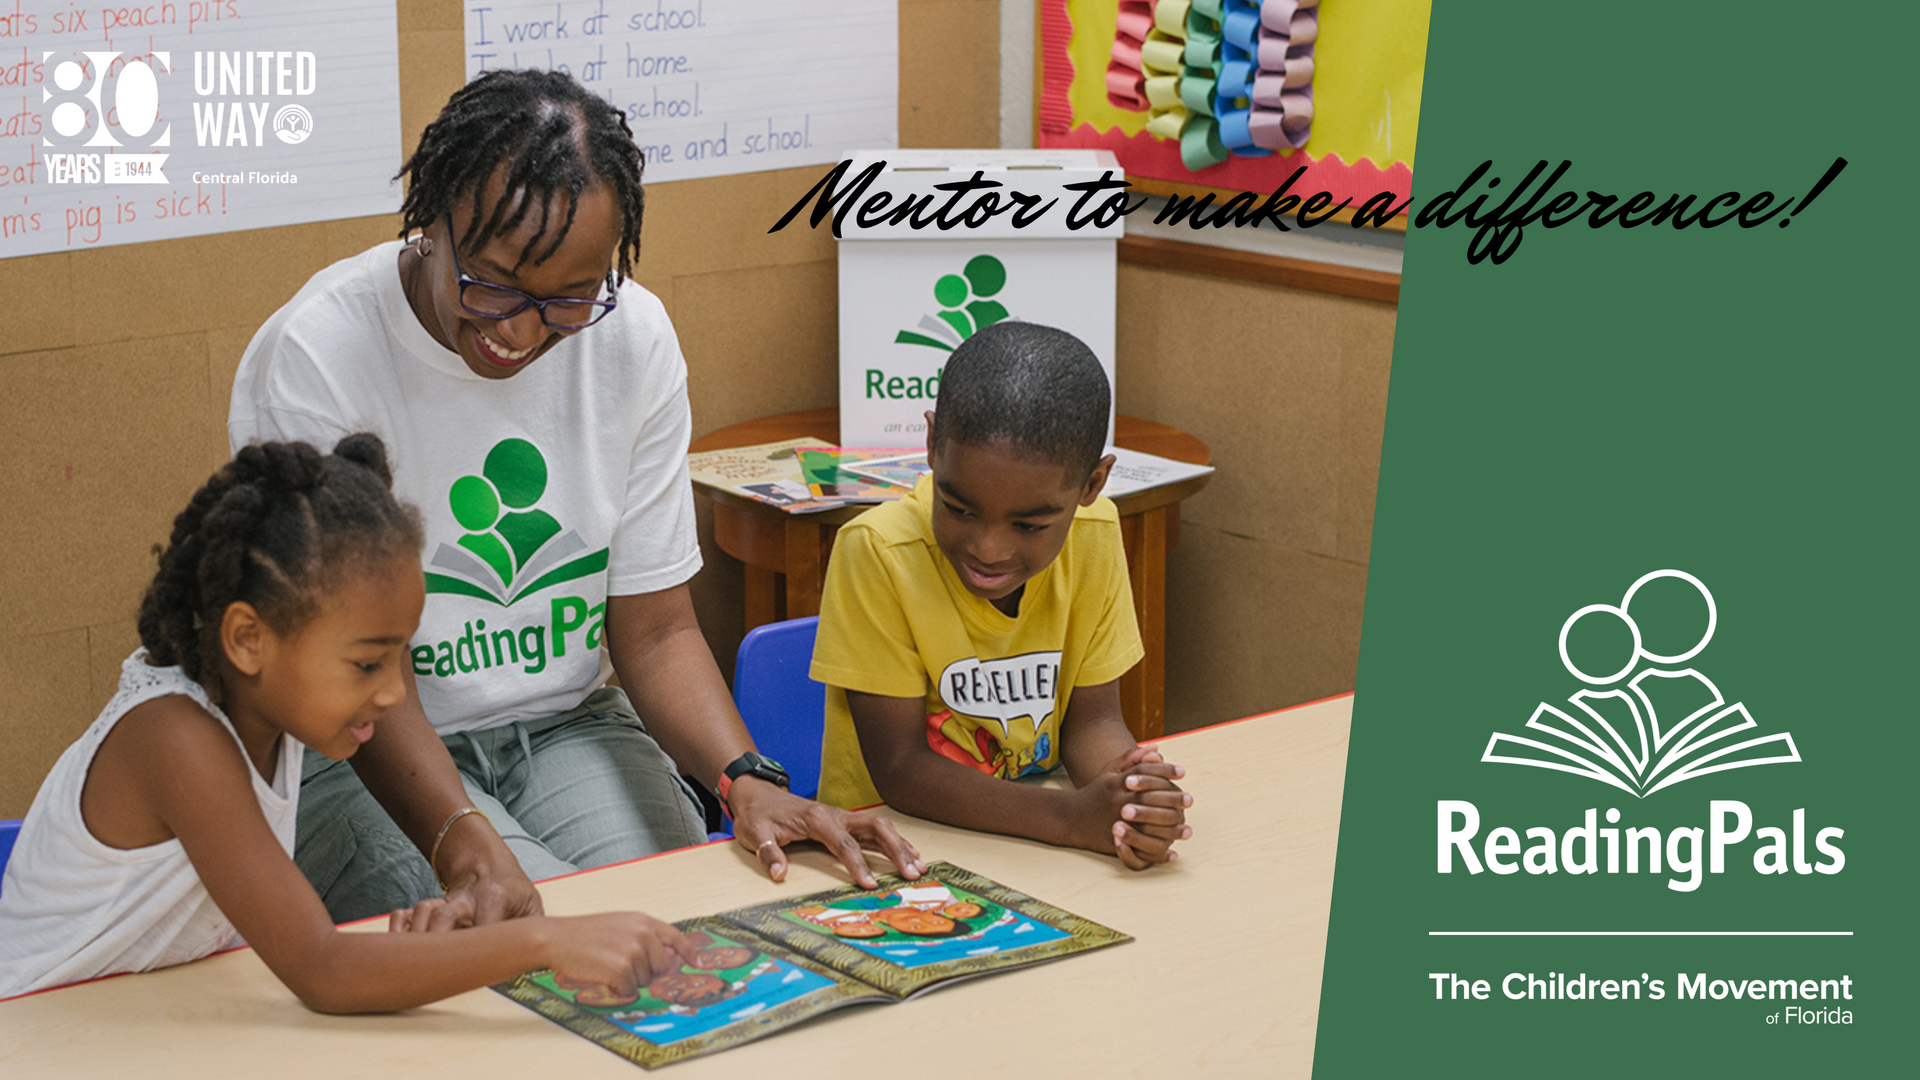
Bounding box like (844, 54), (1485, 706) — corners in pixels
(1436, 569), (1847, 892)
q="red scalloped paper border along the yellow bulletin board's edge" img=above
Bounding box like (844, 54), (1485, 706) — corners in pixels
(1035, 0), (1413, 206)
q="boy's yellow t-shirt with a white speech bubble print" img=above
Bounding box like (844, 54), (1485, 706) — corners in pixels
(812, 479), (1146, 807)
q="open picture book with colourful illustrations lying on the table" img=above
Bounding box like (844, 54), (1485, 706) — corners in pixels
(493, 863), (1133, 1068)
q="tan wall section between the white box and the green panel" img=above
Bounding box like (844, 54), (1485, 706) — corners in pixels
(1114, 263), (1396, 732)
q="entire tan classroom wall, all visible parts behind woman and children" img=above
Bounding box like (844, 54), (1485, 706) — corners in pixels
(0, 0), (1394, 817)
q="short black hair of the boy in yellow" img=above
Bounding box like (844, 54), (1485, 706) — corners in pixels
(933, 319), (1112, 479)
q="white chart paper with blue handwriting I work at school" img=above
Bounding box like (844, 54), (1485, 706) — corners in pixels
(467, 0), (900, 183)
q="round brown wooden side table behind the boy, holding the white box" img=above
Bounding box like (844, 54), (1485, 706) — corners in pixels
(691, 407), (1212, 740)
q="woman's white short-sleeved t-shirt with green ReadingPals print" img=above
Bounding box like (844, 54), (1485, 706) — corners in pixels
(227, 240), (701, 734)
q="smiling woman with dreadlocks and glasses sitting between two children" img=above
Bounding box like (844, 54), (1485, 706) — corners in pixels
(228, 71), (922, 922)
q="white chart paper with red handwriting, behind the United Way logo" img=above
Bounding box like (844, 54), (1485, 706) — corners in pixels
(0, 0), (399, 258)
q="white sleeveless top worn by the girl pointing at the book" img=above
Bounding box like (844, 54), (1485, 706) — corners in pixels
(0, 650), (303, 997)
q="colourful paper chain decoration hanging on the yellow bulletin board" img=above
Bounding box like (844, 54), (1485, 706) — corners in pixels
(1106, 0), (1319, 173)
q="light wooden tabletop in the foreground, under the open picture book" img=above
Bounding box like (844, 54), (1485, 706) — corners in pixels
(0, 696), (1352, 1080)
